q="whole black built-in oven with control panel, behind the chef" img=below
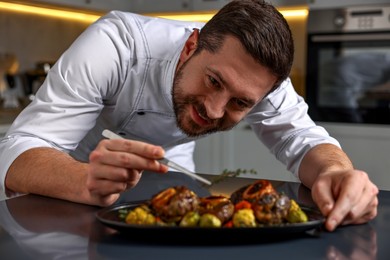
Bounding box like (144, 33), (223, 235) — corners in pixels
(306, 4), (390, 124)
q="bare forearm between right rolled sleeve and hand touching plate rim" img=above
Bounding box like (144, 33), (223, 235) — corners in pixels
(299, 144), (353, 188)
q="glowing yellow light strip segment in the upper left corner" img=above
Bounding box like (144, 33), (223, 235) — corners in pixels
(0, 2), (100, 23)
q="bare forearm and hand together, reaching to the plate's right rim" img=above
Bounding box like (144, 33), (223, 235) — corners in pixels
(299, 144), (378, 231)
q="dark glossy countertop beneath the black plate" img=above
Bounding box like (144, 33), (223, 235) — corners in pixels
(0, 173), (390, 260)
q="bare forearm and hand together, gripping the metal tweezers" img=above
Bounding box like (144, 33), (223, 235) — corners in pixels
(5, 139), (168, 206)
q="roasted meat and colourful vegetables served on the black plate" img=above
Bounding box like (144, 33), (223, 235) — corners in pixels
(117, 180), (310, 228)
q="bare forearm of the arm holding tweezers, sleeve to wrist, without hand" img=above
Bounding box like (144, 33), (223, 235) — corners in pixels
(5, 148), (90, 203)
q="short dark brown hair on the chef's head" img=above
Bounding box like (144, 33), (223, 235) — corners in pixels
(196, 0), (294, 87)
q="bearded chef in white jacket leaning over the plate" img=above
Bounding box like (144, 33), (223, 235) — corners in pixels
(0, 0), (378, 230)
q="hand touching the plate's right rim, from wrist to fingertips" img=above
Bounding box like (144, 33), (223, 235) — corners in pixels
(312, 170), (378, 231)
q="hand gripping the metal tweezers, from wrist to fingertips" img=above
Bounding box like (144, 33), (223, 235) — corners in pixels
(87, 139), (168, 205)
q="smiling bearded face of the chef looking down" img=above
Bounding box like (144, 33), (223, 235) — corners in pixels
(172, 37), (276, 137)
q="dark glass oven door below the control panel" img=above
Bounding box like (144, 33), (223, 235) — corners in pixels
(306, 31), (390, 124)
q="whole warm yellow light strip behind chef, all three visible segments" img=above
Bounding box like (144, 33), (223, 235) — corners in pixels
(0, 2), (308, 23)
